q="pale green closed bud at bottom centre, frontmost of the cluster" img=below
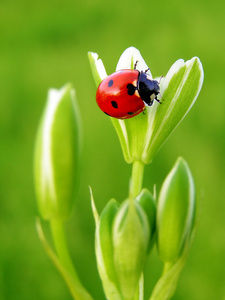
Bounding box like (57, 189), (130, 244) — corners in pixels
(113, 200), (150, 300)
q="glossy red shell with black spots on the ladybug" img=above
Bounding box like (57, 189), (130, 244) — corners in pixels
(96, 70), (145, 119)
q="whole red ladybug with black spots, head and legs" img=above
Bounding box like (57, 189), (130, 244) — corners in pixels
(96, 62), (161, 119)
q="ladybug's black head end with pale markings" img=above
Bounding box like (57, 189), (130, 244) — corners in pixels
(137, 71), (160, 106)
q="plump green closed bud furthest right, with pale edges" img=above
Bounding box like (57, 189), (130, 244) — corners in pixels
(157, 158), (195, 263)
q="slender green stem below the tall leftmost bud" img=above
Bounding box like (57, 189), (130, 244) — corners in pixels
(51, 220), (93, 300)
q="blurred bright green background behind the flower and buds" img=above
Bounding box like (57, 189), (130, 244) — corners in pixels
(0, 0), (225, 300)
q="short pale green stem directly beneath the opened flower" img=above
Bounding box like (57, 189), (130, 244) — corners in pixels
(130, 160), (145, 199)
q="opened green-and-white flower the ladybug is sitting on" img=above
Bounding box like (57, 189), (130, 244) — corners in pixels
(89, 47), (203, 164)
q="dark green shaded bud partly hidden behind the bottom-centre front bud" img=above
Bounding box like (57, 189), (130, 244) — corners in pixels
(135, 189), (156, 252)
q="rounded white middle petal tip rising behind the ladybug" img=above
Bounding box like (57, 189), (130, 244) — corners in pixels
(116, 47), (152, 78)
